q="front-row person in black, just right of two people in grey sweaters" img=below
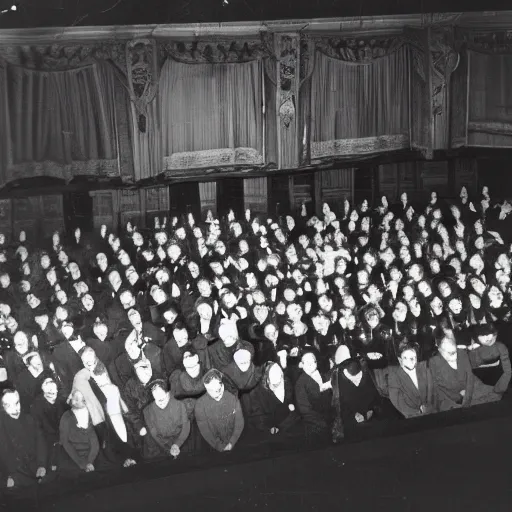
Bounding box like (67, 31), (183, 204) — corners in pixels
(246, 361), (300, 435)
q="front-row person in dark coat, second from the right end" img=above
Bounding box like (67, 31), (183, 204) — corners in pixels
(430, 333), (501, 411)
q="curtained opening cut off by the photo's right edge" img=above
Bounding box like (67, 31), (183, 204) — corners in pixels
(468, 52), (512, 147)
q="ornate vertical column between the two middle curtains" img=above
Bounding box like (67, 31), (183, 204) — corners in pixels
(274, 33), (300, 169)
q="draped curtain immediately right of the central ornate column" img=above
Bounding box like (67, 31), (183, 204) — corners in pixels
(310, 45), (410, 158)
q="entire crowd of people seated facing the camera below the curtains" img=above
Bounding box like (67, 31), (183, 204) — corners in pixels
(0, 188), (512, 488)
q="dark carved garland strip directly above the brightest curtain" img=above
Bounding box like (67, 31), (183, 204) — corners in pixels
(160, 34), (273, 64)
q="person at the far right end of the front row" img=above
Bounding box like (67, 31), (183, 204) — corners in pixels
(469, 324), (512, 393)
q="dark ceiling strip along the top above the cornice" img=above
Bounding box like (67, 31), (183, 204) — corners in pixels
(0, 0), (510, 28)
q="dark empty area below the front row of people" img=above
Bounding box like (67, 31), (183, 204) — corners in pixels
(5, 393), (512, 512)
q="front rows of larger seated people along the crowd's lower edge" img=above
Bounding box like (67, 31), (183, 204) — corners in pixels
(0, 323), (512, 487)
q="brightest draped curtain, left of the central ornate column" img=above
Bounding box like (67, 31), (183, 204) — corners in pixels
(159, 58), (263, 170)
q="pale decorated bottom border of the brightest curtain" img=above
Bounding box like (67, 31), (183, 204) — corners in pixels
(164, 148), (264, 171)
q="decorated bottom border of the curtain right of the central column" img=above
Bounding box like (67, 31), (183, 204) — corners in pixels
(311, 134), (410, 163)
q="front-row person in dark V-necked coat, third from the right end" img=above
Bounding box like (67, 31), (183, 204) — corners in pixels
(387, 341), (437, 418)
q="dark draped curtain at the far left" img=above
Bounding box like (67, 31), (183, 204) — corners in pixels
(0, 63), (119, 186)
